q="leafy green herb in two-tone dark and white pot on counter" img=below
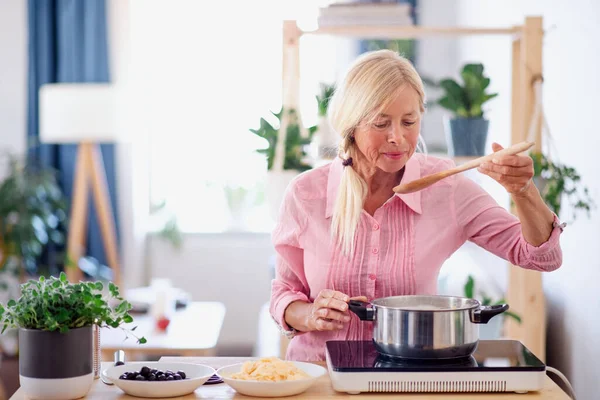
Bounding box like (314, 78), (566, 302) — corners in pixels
(0, 272), (146, 400)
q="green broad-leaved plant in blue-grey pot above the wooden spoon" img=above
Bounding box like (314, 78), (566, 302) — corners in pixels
(437, 64), (498, 157)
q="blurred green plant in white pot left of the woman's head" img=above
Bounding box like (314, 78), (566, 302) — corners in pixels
(250, 108), (317, 219)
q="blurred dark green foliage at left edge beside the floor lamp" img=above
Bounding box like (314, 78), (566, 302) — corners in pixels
(0, 155), (67, 275)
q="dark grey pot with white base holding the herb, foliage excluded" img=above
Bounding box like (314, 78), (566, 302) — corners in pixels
(19, 326), (94, 400)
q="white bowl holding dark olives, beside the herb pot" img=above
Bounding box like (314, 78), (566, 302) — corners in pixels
(102, 361), (215, 398)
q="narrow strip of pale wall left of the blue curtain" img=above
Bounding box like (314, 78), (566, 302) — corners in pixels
(0, 0), (27, 176)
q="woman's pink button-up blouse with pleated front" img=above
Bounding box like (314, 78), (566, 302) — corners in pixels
(270, 153), (562, 361)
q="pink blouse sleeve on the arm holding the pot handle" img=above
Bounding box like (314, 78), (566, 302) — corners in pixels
(270, 181), (310, 331)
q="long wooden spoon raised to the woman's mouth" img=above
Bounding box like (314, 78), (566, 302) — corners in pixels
(394, 142), (535, 194)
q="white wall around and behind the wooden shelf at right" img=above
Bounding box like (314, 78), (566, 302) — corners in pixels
(456, 0), (600, 399)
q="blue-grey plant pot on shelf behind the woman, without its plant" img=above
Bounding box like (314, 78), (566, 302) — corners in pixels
(446, 118), (490, 157)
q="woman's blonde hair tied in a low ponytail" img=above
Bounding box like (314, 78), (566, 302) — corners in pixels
(328, 50), (425, 255)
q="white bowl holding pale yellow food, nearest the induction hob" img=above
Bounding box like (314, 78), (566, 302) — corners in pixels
(217, 361), (327, 397)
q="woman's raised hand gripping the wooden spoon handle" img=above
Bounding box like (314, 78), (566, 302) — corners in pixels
(477, 143), (533, 196)
